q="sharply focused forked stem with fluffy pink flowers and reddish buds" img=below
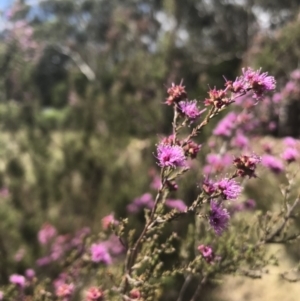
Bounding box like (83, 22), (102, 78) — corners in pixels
(110, 68), (297, 300)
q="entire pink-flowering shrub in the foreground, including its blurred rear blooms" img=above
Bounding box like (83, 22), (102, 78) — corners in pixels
(0, 68), (300, 301)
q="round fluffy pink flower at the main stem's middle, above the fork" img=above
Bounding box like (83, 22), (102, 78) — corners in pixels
(157, 144), (186, 168)
